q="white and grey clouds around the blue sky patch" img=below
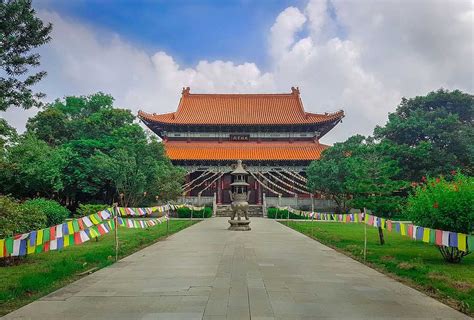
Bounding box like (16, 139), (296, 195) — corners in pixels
(1, 0), (474, 142)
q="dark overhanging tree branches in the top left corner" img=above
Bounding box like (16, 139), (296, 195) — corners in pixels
(0, 0), (52, 111)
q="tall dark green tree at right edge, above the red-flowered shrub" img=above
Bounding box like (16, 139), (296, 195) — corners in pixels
(374, 89), (474, 181)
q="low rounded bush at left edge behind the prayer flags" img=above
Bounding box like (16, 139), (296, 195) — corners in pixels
(0, 196), (48, 238)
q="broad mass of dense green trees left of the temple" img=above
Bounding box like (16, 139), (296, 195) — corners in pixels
(4, 93), (184, 208)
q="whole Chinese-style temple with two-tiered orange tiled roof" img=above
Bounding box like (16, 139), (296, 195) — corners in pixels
(138, 87), (344, 214)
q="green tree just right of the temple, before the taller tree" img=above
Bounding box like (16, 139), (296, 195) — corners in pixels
(308, 136), (406, 216)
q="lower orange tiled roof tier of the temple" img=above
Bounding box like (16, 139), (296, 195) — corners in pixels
(164, 141), (328, 160)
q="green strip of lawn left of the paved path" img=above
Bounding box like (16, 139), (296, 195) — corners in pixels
(0, 220), (197, 316)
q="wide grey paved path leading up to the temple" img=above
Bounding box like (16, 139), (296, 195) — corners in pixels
(5, 218), (470, 320)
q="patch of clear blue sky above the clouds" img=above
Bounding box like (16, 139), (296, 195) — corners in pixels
(35, 0), (306, 68)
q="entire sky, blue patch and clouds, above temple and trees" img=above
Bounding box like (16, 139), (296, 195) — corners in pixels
(3, 0), (474, 143)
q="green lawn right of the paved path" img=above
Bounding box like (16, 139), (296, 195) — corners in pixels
(281, 221), (474, 316)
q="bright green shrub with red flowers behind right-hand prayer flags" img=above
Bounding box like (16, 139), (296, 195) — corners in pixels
(406, 174), (474, 262)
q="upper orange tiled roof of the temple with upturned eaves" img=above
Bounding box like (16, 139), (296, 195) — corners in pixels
(138, 87), (344, 125)
